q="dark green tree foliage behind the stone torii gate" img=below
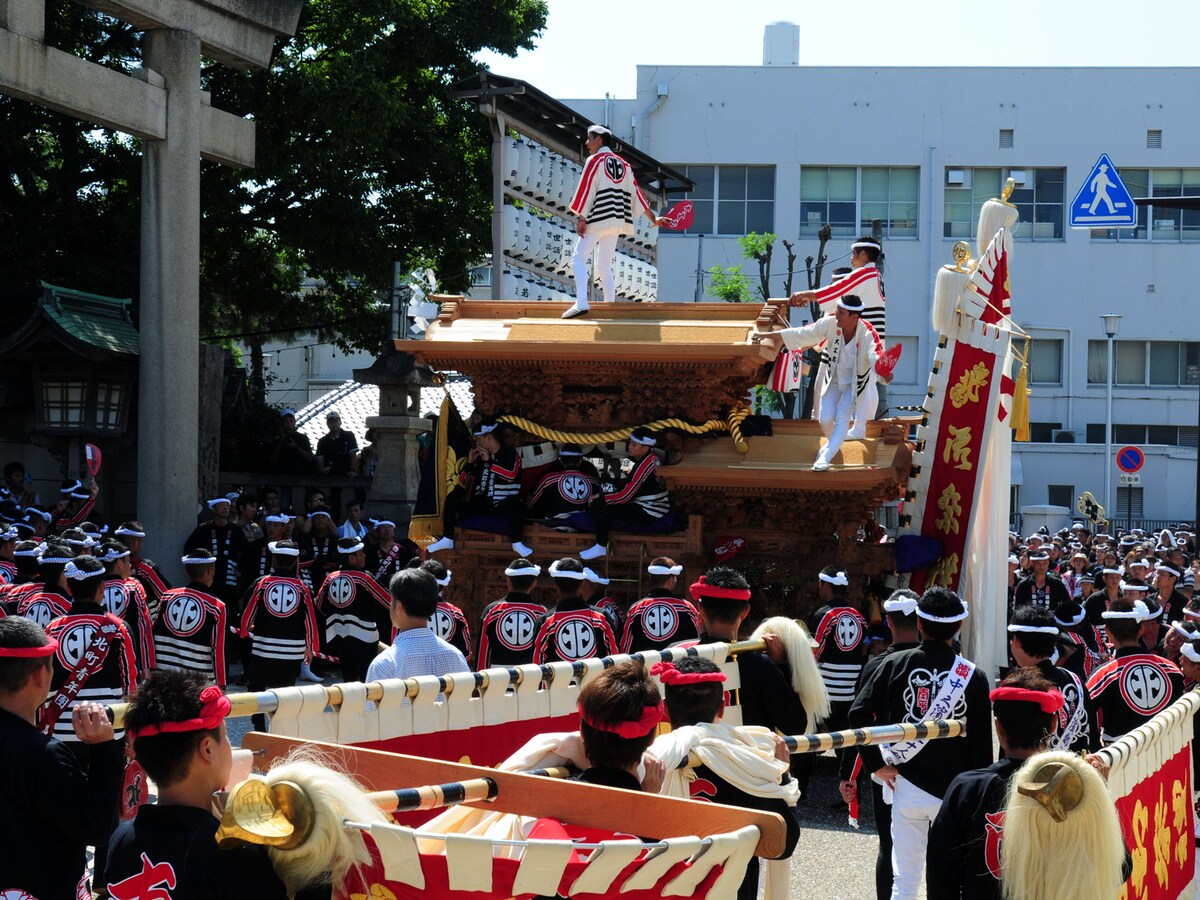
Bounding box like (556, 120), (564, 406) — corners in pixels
(0, 0), (546, 364)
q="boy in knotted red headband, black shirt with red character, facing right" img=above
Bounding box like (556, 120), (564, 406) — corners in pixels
(106, 671), (288, 900)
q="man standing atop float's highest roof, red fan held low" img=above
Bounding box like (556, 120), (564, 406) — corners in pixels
(563, 125), (662, 319)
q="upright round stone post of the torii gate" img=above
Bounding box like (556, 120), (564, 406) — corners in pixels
(137, 30), (200, 584)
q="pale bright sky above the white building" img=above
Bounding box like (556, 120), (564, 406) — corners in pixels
(480, 0), (1200, 98)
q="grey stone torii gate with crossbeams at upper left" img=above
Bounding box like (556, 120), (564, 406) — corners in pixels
(0, 0), (302, 576)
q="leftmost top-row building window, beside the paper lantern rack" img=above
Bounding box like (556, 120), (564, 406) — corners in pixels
(679, 166), (775, 236)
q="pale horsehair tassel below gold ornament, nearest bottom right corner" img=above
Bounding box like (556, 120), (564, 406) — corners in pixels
(1001, 750), (1126, 900)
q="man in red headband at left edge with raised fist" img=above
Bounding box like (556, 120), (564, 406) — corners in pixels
(0, 616), (122, 898)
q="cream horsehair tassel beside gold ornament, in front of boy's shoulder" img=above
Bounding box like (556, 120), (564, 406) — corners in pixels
(266, 748), (391, 895)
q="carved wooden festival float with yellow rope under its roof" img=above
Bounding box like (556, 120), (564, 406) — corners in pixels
(396, 296), (912, 620)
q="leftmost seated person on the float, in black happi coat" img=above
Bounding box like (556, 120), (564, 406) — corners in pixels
(426, 420), (533, 557)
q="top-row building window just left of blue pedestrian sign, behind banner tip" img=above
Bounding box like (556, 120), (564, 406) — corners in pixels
(942, 167), (1067, 240)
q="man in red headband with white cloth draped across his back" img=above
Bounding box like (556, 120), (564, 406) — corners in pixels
(649, 656), (800, 900)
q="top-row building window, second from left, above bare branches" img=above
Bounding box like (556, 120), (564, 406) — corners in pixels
(800, 166), (920, 238)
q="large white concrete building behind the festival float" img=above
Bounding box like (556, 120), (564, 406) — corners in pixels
(564, 33), (1200, 522)
